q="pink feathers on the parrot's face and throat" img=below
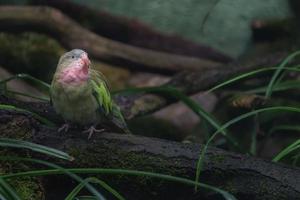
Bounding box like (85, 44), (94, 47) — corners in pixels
(58, 53), (91, 85)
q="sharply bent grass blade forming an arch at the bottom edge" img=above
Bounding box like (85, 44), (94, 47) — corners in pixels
(65, 177), (125, 200)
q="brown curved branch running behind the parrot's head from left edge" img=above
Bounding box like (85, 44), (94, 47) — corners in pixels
(0, 6), (218, 73)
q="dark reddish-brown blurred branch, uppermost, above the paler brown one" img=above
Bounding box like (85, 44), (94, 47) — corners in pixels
(31, 0), (232, 63)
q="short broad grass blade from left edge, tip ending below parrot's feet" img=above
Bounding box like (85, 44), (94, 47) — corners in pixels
(0, 138), (74, 161)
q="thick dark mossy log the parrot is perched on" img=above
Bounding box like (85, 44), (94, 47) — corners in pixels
(0, 98), (300, 200)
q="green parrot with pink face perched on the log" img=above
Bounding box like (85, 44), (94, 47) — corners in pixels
(50, 49), (131, 139)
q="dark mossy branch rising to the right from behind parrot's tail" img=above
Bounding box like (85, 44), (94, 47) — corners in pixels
(116, 52), (287, 119)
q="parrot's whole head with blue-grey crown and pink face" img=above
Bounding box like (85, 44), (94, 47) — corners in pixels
(56, 49), (91, 85)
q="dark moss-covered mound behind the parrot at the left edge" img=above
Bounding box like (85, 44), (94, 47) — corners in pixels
(0, 32), (64, 81)
